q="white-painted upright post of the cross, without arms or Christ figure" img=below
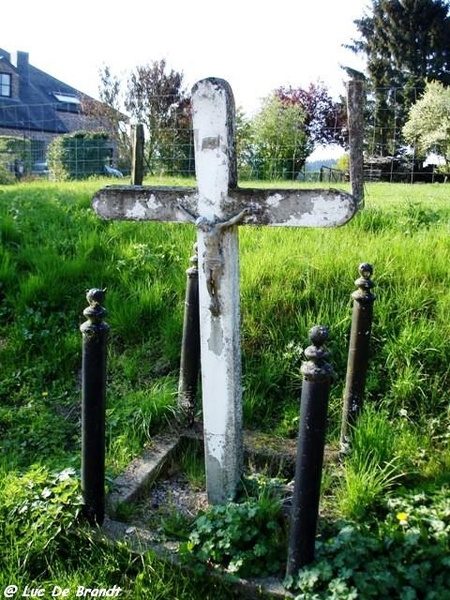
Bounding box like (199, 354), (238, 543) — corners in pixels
(192, 79), (242, 503)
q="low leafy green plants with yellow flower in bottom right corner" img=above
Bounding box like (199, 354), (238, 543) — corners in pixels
(284, 488), (450, 600)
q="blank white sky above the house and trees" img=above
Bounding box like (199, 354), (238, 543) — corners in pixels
(0, 0), (371, 113)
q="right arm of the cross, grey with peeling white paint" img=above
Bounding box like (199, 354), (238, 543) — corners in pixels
(227, 188), (358, 227)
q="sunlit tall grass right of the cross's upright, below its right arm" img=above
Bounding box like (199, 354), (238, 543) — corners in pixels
(241, 184), (450, 436)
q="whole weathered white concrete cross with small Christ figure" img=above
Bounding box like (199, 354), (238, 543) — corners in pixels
(92, 78), (356, 503)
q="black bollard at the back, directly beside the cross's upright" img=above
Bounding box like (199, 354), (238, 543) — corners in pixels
(178, 244), (200, 426)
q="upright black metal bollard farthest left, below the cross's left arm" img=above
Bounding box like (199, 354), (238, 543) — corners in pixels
(80, 288), (109, 525)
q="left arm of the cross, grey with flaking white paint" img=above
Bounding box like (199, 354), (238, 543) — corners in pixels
(92, 185), (198, 223)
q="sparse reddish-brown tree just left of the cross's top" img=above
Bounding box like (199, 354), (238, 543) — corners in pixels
(125, 60), (193, 174)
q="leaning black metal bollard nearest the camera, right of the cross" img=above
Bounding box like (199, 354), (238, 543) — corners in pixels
(286, 326), (333, 575)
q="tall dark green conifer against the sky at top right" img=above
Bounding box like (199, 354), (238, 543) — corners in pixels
(347, 0), (450, 155)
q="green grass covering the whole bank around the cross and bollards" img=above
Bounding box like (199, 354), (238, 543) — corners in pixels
(0, 180), (450, 600)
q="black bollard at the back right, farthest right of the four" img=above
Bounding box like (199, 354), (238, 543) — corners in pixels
(340, 263), (375, 454)
